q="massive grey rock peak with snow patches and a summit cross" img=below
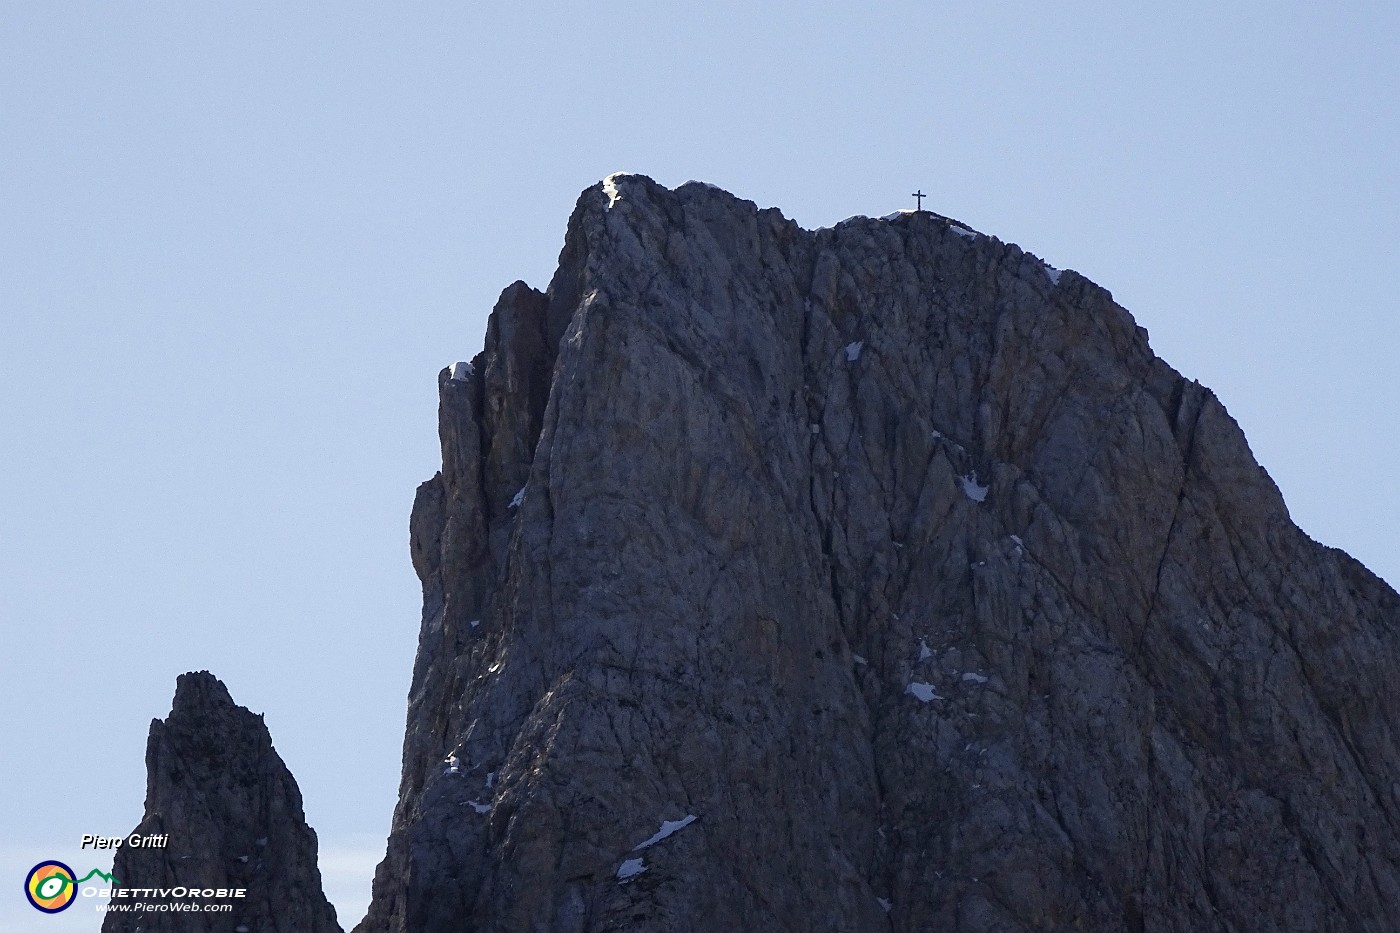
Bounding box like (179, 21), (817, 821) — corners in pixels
(352, 177), (1400, 933)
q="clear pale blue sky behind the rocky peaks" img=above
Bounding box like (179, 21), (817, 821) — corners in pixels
(0, 0), (1400, 930)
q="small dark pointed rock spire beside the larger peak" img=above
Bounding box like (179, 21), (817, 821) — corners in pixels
(102, 671), (340, 933)
